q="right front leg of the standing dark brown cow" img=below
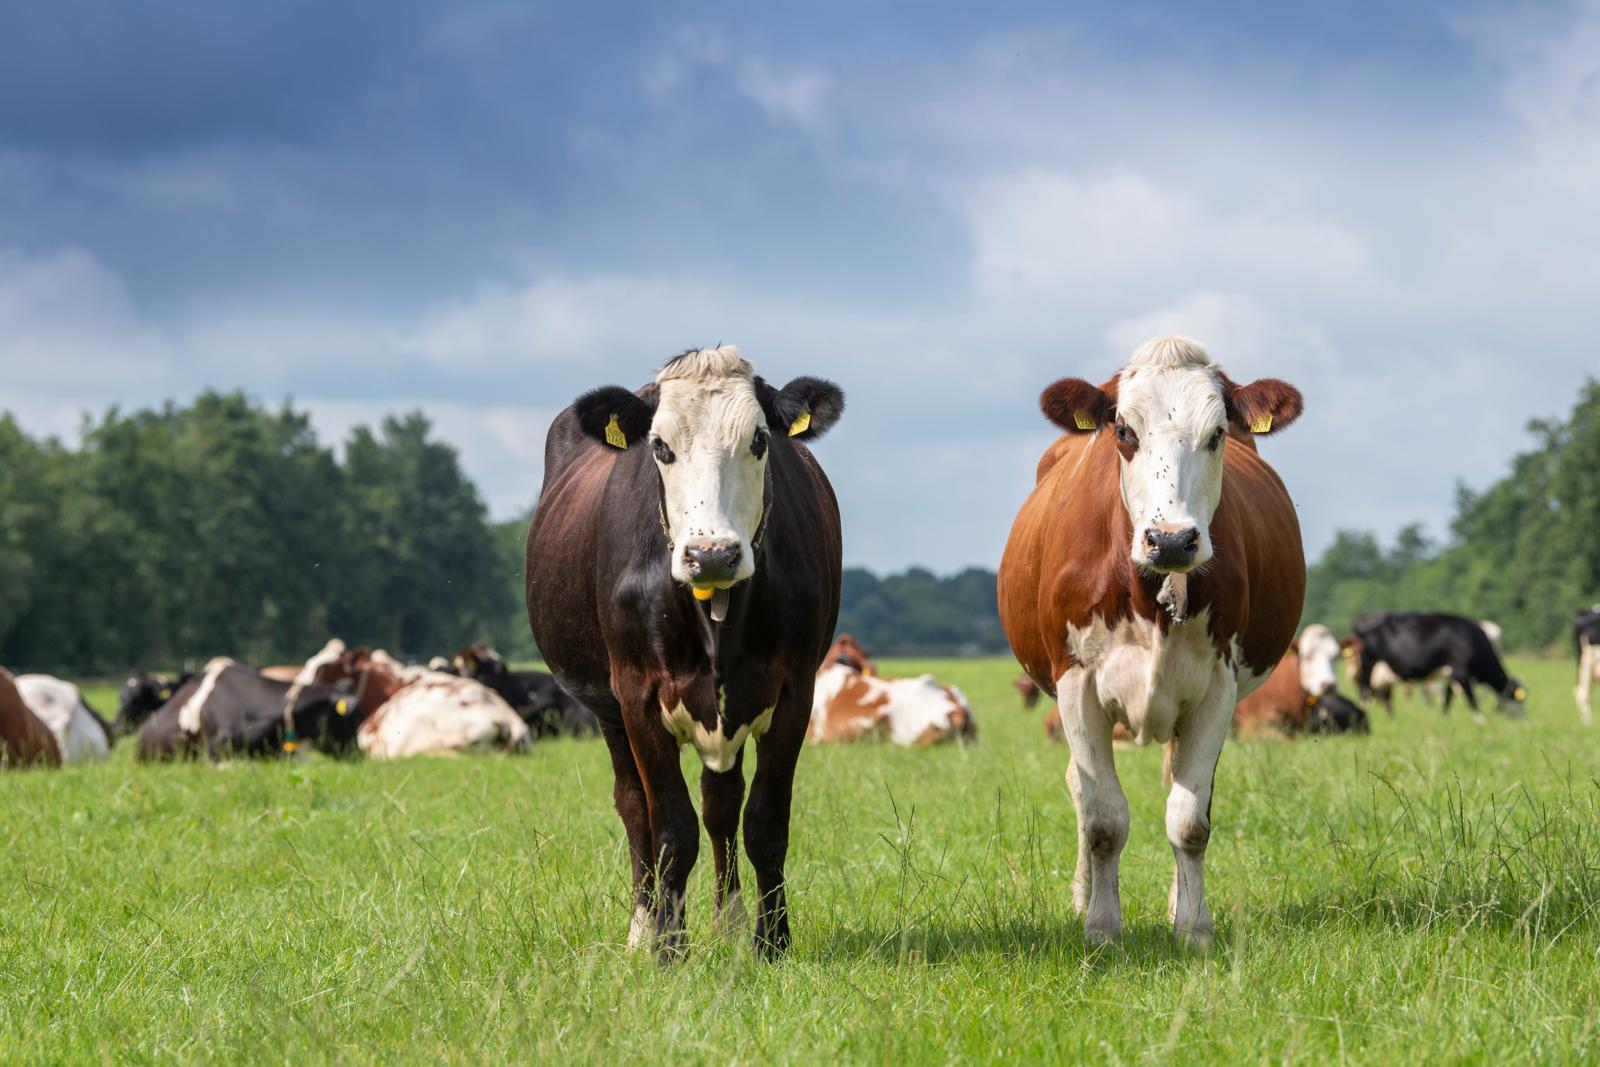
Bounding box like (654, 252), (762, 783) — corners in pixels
(744, 685), (811, 958)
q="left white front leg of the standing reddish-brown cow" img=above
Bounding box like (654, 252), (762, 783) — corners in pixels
(1056, 667), (1128, 945)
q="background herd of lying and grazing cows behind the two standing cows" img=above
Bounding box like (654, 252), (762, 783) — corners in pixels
(12, 605), (1600, 766)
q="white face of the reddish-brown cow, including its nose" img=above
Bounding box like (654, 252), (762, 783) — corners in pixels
(1114, 365), (1227, 574)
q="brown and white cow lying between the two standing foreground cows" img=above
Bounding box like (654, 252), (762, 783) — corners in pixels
(806, 664), (978, 749)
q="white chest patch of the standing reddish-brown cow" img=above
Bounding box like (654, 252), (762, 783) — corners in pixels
(1067, 611), (1235, 744)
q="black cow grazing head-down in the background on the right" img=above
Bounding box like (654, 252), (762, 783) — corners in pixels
(1352, 611), (1528, 718)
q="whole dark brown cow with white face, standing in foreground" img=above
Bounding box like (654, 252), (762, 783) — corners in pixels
(526, 347), (843, 957)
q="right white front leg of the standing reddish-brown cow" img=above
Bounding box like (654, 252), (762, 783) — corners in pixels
(1166, 667), (1238, 949)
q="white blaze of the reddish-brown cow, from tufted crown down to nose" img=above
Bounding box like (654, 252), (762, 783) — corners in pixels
(1117, 336), (1227, 569)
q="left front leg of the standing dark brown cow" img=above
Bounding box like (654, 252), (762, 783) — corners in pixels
(622, 696), (699, 960)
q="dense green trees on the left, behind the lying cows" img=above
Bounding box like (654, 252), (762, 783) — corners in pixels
(0, 392), (526, 673)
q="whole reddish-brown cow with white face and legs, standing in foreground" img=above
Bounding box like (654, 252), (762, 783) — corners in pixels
(1000, 338), (1306, 947)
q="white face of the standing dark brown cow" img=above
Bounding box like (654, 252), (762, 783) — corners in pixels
(650, 360), (770, 589)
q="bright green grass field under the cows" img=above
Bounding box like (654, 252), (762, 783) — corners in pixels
(0, 661), (1600, 1064)
